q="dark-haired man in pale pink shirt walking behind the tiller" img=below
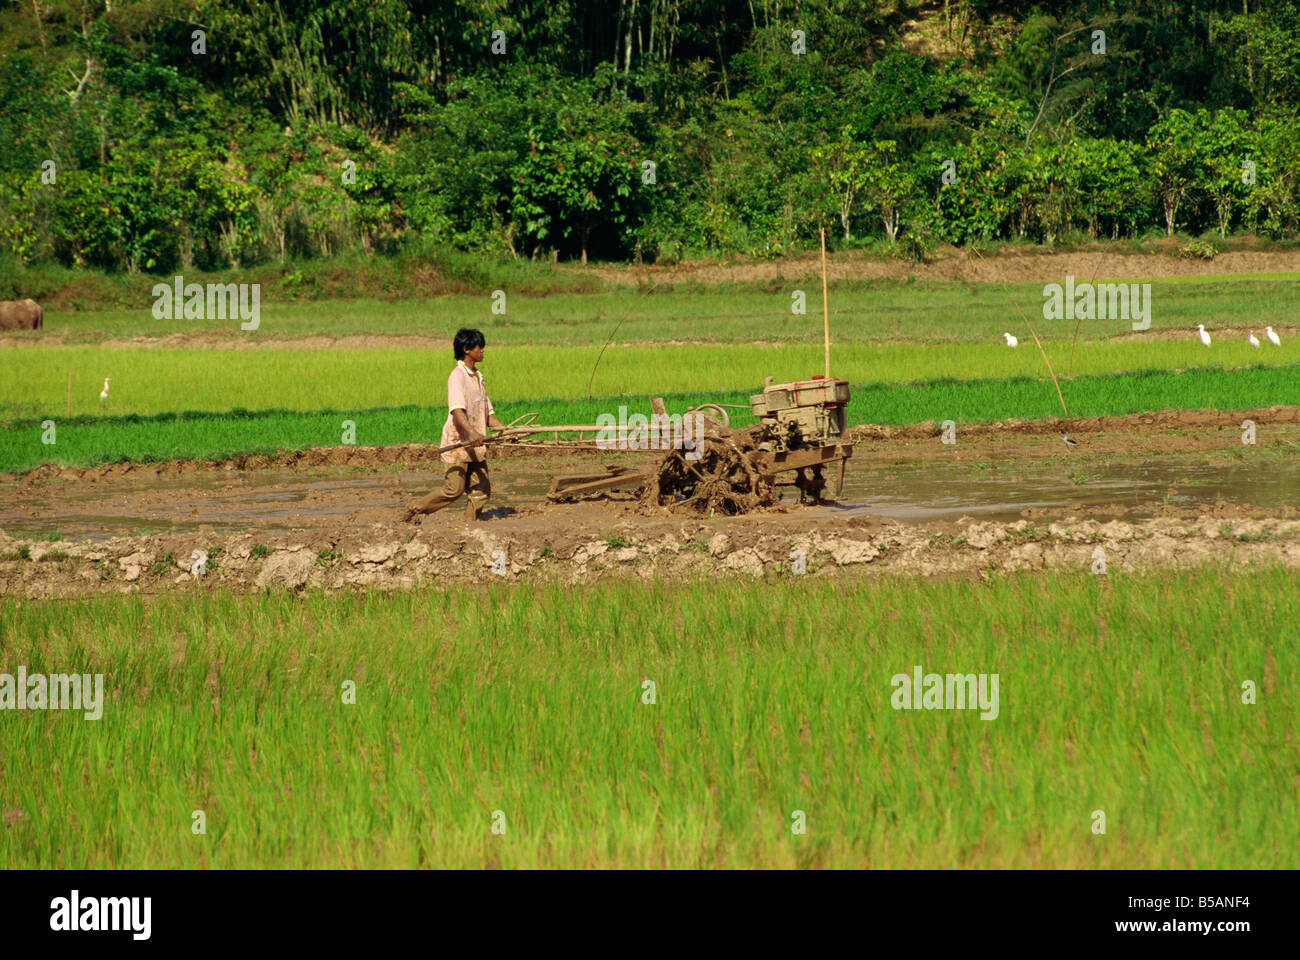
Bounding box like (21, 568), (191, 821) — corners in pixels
(403, 329), (506, 523)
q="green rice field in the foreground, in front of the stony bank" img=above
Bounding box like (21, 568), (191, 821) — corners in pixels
(0, 568), (1300, 869)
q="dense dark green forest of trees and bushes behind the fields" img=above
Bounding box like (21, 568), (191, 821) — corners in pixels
(0, 0), (1300, 274)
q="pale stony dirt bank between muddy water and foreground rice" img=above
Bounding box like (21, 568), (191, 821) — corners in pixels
(0, 515), (1300, 598)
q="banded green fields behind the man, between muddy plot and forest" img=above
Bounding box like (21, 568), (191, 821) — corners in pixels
(0, 267), (1300, 472)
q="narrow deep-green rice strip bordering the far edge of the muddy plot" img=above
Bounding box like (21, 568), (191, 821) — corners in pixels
(0, 366), (1300, 473)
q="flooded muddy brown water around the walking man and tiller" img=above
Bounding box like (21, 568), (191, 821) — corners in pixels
(0, 457), (1300, 542)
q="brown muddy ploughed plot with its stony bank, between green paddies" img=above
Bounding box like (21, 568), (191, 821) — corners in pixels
(0, 407), (1300, 598)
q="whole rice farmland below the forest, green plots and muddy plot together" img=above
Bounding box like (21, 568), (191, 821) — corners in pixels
(0, 256), (1300, 870)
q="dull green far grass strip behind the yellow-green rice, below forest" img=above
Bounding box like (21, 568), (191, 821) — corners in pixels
(7, 273), (1300, 346)
